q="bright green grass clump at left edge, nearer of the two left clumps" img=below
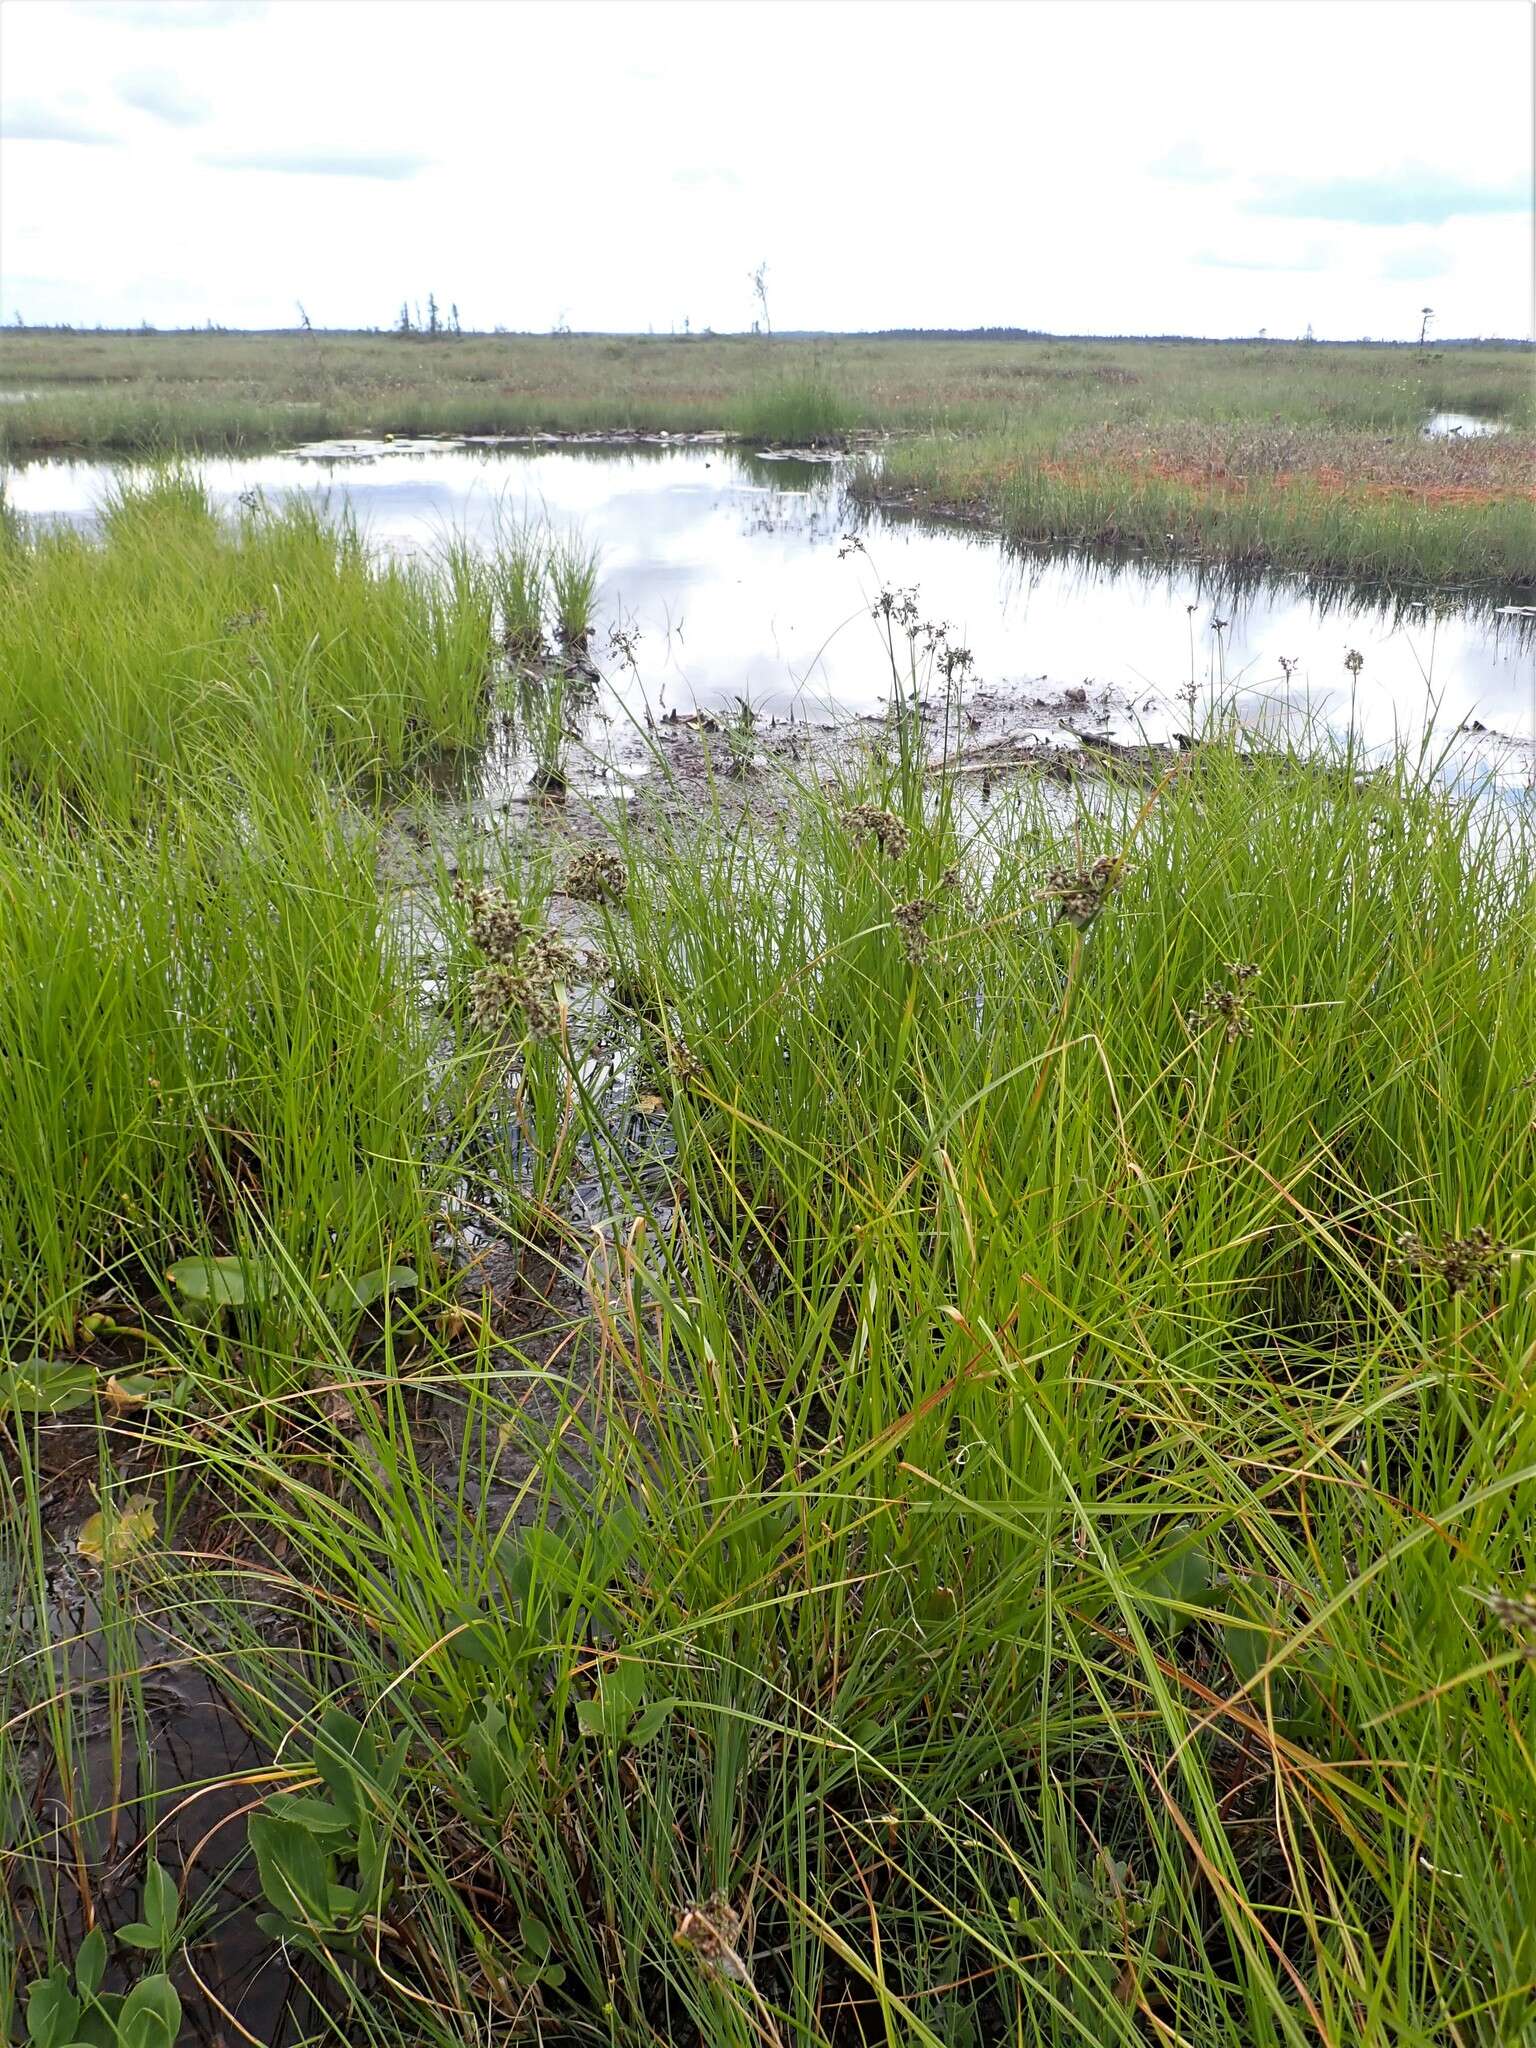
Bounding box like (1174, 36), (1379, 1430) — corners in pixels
(0, 762), (449, 1356)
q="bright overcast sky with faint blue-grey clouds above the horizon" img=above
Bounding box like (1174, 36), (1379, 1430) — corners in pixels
(0, 0), (1532, 338)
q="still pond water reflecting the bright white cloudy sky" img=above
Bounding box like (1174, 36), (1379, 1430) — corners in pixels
(6, 436), (1536, 786)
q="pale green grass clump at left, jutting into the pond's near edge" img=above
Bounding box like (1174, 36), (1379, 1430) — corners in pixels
(0, 469), (498, 815)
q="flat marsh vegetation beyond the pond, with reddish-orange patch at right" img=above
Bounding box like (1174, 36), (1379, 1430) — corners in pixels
(0, 330), (1536, 594)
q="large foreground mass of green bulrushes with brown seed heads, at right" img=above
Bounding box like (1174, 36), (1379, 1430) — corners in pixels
(75, 741), (1536, 2048)
